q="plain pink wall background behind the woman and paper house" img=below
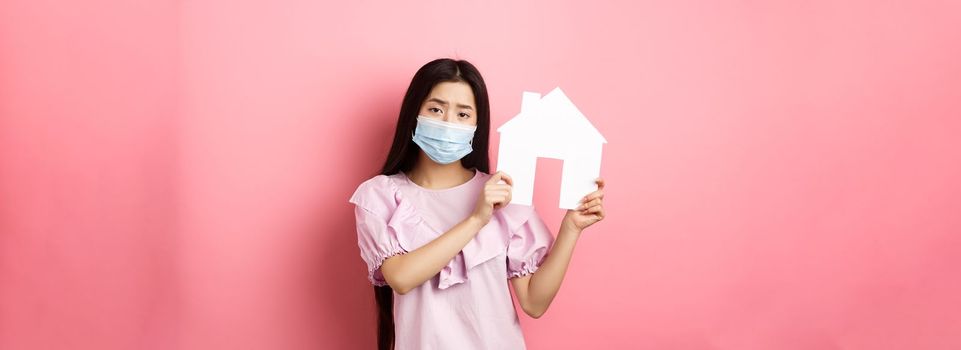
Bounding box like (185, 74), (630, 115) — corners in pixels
(0, 0), (961, 349)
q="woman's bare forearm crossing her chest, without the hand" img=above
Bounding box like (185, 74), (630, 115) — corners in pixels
(380, 216), (486, 294)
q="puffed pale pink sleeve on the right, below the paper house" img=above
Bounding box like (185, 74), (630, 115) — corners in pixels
(507, 206), (554, 278)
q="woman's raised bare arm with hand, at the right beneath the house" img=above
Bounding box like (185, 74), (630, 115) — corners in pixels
(511, 179), (604, 318)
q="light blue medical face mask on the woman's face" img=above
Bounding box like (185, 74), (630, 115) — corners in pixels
(413, 115), (477, 164)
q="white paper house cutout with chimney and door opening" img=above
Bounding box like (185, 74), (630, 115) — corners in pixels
(497, 87), (607, 209)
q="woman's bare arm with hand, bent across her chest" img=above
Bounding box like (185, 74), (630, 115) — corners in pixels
(380, 172), (511, 294)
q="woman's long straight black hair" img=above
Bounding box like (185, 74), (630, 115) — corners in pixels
(374, 58), (490, 350)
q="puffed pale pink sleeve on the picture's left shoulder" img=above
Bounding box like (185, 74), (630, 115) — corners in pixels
(349, 175), (411, 286)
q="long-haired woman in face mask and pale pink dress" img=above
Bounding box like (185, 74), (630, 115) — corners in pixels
(350, 59), (604, 349)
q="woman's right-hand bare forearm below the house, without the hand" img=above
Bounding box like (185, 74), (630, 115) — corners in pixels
(525, 225), (581, 318)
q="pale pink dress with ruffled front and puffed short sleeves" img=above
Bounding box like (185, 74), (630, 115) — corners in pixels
(350, 170), (554, 350)
